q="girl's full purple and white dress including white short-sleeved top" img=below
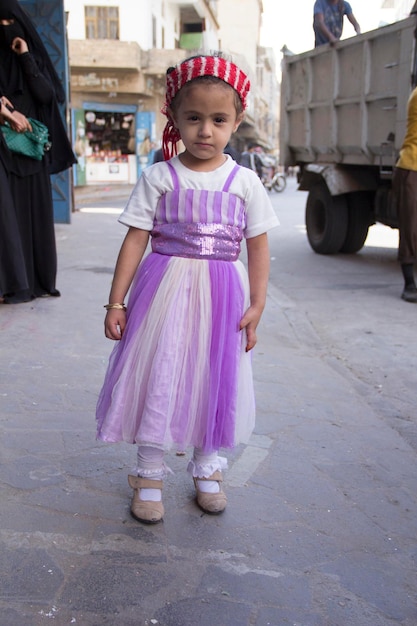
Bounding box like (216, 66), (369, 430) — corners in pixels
(97, 157), (278, 452)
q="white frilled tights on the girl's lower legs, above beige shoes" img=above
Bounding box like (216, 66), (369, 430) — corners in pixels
(137, 446), (227, 502)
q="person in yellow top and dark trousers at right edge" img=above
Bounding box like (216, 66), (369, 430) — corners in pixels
(392, 88), (417, 302)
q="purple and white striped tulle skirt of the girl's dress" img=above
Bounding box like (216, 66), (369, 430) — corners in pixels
(97, 253), (255, 451)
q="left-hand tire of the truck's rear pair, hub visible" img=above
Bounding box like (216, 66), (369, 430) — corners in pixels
(305, 183), (348, 254)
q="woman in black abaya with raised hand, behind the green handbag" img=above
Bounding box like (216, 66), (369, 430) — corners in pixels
(0, 0), (76, 303)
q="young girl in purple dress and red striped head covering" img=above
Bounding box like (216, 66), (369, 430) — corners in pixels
(97, 56), (278, 523)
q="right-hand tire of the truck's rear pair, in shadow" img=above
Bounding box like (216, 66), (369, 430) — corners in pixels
(340, 192), (372, 254)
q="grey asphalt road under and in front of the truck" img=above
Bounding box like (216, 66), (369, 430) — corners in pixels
(270, 179), (417, 454)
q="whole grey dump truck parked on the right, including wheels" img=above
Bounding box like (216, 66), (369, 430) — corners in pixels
(280, 2), (417, 254)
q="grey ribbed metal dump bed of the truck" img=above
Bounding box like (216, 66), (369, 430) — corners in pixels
(280, 15), (416, 168)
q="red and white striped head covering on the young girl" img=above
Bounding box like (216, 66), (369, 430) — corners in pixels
(162, 55), (250, 160)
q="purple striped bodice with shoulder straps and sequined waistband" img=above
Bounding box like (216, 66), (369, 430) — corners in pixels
(151, 163), (245, 261)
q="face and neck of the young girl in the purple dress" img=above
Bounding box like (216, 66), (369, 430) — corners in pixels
(170, 81), (243, 171)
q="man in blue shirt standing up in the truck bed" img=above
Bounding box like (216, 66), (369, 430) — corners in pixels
(313, 0), (361, 48)
